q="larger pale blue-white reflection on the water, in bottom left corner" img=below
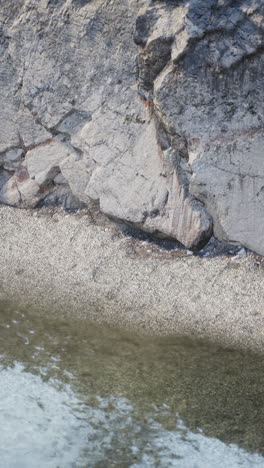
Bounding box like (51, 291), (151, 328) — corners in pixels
(0, 364), (88, 468)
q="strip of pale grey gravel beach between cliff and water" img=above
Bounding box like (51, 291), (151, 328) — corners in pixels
(0, 206), (264, 353)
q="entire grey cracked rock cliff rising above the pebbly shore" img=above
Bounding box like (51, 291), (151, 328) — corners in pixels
(0, 0), (264, 255)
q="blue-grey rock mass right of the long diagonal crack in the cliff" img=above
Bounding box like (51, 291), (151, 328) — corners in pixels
(137, 0), (264, 254)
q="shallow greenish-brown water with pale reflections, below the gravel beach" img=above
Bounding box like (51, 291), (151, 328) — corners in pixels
(0, 304), (264, 468)
